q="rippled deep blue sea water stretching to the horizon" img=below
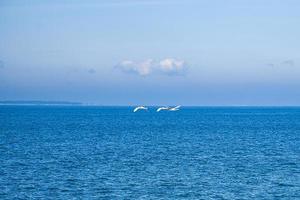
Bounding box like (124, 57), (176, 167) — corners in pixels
(0, 106), (300, 199)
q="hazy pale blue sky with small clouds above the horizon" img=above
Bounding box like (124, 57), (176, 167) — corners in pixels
(0, 0), (300, 106)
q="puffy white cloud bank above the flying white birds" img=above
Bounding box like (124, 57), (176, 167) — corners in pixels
(115, 58), (187, 76)
